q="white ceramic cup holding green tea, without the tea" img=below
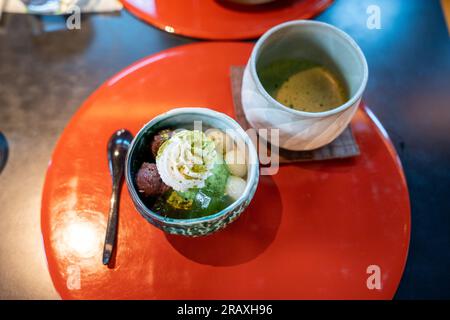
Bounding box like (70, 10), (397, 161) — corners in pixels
(242, 20), (369, 151)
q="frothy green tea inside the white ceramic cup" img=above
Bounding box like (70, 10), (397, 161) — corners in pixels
(257, 59), (349, 112)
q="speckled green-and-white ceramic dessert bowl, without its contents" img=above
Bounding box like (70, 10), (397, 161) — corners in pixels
(125, 108), (259, 237)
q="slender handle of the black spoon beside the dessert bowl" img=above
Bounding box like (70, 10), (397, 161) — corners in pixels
(103, 183), (121, 265)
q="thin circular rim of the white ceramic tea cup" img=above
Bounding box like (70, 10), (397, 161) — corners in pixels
(249, 20), (369, 118)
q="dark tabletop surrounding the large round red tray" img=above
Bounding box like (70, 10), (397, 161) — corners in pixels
(0, 0), (450, 299)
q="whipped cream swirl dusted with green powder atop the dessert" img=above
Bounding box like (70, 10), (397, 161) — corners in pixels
(156, 130), (217, 191)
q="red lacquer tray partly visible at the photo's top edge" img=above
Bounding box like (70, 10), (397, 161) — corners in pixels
(121, 0), (333, 40)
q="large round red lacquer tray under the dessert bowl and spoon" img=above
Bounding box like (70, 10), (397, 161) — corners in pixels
(41, 43), (410, 299)
